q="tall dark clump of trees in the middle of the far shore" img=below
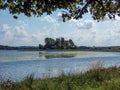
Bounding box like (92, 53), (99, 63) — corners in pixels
(39, 37), (76, 49)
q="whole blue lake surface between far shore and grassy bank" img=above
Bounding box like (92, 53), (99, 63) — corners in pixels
(0, 50), (120, 81)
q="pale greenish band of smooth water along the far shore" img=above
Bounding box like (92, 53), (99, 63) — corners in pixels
(0, 50), (120, 61)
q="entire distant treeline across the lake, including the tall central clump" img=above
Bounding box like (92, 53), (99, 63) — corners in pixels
(0, 37), (120, 52)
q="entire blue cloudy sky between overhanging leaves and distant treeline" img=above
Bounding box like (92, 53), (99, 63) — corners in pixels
(0, 10), (120, 46)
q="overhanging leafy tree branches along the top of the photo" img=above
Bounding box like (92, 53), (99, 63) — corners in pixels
(0, 0), (120, 21)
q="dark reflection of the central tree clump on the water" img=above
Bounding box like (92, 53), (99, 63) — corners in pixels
(39, 52), (76, 59)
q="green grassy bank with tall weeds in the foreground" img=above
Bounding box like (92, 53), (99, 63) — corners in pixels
(0, 61), (120, 90)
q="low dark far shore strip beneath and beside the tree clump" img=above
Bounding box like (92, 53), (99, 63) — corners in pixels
(0, 45), (120, 52)
